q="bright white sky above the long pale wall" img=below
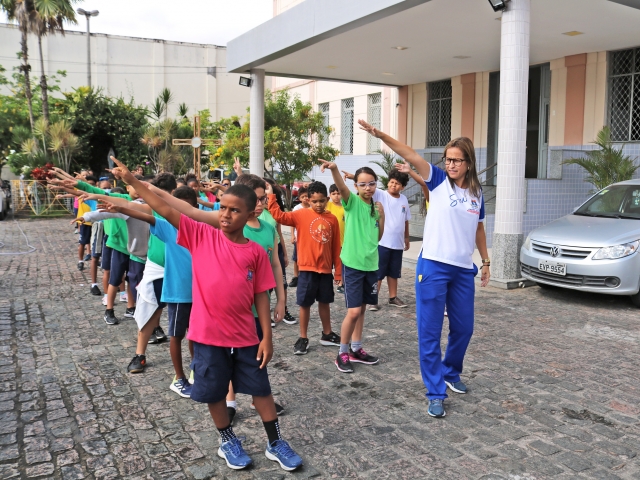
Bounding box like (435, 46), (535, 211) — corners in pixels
(0, 0), (273, 45)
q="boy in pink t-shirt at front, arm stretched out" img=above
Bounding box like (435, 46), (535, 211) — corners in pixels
(111, 157), (302, 471)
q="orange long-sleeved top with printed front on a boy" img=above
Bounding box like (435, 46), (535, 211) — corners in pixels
(269, 194), (342, 280)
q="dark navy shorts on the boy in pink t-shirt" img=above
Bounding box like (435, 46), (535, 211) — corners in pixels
(191, 342), (271, 403)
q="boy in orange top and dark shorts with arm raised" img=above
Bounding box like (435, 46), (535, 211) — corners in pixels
(266, 182), (342, 355)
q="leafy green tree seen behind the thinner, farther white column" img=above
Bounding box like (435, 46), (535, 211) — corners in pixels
(211, 90), (339, 206)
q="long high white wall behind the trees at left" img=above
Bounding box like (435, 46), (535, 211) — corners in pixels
(0, 24), (249, 120)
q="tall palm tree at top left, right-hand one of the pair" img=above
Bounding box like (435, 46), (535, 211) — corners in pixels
(32, 0), (77, 123)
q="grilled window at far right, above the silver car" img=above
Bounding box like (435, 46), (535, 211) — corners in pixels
(609, 48), (640, 142)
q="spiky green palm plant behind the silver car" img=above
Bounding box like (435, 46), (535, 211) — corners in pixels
(562, 127), (640, 193)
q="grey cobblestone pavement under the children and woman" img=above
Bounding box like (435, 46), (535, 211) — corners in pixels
(0, 220), (640, 479)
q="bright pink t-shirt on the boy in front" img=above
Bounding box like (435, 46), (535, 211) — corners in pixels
(177, 215), (276, 348)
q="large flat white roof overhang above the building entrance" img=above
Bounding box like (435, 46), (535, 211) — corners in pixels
(227, 0), (640, 86)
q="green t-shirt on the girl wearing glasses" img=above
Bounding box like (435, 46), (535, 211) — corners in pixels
(340, 193), (380, 272)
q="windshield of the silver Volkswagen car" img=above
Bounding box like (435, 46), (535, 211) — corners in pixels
(573, 185), (640, 220)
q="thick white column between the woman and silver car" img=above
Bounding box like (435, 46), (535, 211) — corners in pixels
(491, 0), (531, 288)
